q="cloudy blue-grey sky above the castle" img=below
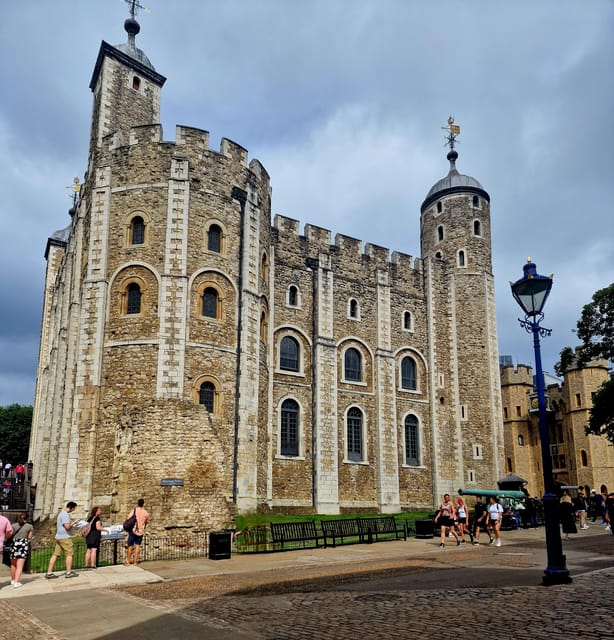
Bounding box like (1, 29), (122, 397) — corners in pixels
(0, 0), (614, 405)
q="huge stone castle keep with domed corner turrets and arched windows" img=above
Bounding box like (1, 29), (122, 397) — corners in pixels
(31, 16), (505, 530)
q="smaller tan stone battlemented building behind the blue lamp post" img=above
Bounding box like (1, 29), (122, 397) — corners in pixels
(501, 360), (614, 496)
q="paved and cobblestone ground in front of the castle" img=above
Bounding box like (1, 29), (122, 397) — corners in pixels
(0, 535), (614, 640)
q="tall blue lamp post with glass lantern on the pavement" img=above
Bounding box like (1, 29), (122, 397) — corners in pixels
(510, 258), (571, 585)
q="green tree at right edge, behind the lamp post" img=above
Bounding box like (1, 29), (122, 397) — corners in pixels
(555, 282), (614, 444)
